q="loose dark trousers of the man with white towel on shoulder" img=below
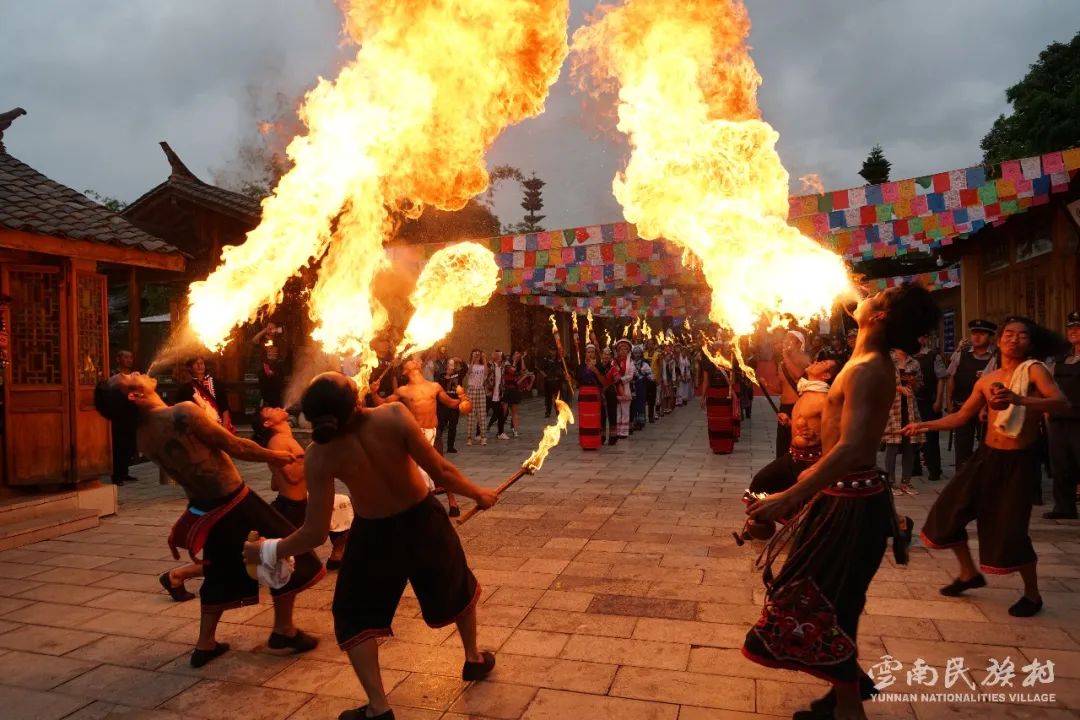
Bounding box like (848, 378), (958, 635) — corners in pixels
(921, 445), (1042, 575)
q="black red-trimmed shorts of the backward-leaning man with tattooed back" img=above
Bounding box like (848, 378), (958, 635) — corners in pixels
(199, 491), (326, 612)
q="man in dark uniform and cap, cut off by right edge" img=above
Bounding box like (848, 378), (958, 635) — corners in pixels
(1042, 310), (1080, 520)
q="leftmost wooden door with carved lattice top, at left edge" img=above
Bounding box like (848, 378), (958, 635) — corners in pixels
(2, 266), (71, 486)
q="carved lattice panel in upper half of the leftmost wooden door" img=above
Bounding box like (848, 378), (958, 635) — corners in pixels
(11, 270), (63, 385)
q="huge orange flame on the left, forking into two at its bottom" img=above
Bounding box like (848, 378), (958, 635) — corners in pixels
(190, 0), (569, 386)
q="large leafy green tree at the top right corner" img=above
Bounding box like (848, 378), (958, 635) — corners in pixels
(978, 32), (1080, 165)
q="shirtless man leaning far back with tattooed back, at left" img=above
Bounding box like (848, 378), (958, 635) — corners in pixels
(94, 372), (326, 667)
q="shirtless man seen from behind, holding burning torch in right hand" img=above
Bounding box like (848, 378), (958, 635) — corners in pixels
(244, 372), (498, 720)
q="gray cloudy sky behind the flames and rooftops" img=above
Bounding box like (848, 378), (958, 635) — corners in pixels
(0, 0), (1080, 228)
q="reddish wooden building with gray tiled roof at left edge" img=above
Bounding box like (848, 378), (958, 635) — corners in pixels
(0, 111), (185, 494)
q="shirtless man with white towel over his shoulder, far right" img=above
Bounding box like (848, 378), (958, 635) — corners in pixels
(905, 317), (1069, 617)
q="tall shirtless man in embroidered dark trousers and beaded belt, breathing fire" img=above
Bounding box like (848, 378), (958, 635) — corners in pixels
(743, 284), (941, 718)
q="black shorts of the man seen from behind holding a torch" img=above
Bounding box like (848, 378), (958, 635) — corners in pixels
(334, 495), (480, 650)
